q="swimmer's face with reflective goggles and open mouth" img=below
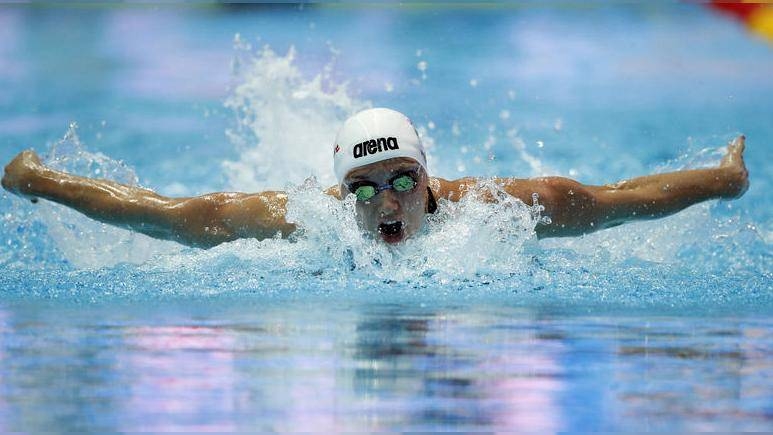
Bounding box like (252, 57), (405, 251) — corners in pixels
(341, 157), (429, 243)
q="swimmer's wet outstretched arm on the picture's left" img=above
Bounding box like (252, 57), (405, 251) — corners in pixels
(2, 151), (295, 248)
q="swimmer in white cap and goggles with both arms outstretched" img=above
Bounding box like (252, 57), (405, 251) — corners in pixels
(2, 108), (749, 248)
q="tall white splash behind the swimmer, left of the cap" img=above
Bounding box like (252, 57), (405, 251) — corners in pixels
(223, 35), (370, 191)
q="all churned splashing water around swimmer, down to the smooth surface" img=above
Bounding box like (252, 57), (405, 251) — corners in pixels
(0, 40), (773, 307)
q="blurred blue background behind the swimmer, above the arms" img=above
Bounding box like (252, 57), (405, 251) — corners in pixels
(0, 2), (773, 194)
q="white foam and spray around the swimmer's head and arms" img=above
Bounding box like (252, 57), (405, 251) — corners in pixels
(10, 39), (769, 294)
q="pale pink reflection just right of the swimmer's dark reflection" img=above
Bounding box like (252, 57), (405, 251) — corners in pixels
(432, 313), (569, 432)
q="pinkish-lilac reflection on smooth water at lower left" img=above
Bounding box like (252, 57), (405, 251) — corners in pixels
(119, 326), (236, 431)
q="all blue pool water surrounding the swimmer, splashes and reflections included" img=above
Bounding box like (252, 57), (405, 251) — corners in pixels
(0, 4), (773, 431)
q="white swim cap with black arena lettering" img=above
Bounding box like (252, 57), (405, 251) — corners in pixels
(333, 108), (427, 183)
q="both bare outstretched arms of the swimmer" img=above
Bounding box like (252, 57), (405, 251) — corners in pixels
(2, 136), (749, 248)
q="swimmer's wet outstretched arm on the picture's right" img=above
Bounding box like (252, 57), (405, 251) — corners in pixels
(438, 136), (749, 238)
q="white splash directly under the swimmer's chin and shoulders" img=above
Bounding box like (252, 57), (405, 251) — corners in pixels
(290, 180), (539, 282)
